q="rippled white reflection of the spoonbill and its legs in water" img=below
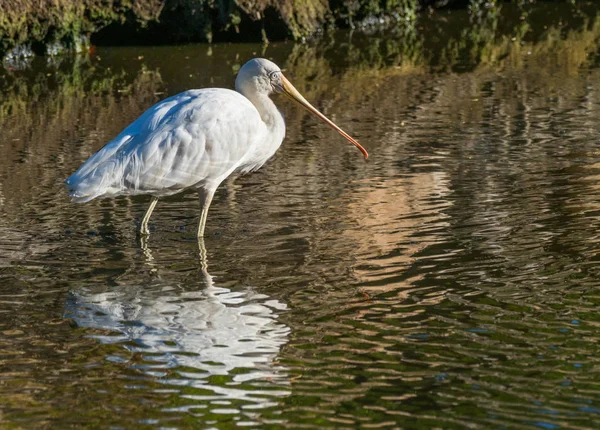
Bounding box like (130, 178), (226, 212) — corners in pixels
(66, 242), (290, 409)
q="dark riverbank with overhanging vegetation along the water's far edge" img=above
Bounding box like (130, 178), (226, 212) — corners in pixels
(0, 0), (579, 62)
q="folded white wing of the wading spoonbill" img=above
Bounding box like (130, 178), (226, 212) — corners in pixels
(67, 88), (266, 201)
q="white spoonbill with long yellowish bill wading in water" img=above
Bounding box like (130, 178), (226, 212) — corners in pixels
(66, 58), (368, 237)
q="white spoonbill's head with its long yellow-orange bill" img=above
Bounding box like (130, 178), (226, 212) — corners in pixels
(235, 58), (369, 158)
